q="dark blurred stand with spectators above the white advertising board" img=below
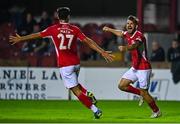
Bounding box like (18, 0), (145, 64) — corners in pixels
(0, 0), (180, 68)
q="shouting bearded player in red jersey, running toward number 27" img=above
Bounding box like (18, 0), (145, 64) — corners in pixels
(103, 15), (161, 118)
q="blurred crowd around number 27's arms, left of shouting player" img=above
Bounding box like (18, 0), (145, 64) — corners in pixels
(0, 11), (117, 61)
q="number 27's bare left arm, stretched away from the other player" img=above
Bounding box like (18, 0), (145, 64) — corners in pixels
(9, 33), (41, 45)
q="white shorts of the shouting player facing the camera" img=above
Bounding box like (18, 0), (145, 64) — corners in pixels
(122, 67), (151, 89)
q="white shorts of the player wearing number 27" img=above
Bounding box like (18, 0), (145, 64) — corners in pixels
(59, 65), (80, 88)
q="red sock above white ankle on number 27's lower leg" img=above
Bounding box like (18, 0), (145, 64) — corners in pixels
(78, 93), (92, 109)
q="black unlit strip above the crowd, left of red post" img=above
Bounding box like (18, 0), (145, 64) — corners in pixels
(0, 0), (136, 17)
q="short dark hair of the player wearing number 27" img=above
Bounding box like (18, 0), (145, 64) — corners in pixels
(57, 7), (70, 20)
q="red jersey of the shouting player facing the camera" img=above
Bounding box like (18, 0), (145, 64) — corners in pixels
(124, 31), (151, 70)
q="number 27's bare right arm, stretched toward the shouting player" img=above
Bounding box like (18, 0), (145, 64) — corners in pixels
(84, 37), (114, 62)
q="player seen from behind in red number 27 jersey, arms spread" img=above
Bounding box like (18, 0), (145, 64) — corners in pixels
(10, 7), (113, 119)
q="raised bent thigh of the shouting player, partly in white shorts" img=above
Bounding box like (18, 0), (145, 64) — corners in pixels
(119, 68), (138, 86)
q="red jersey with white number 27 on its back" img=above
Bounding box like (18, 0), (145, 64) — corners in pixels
(40, 23), (86, 67)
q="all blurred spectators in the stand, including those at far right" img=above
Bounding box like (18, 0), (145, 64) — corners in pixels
(0, 8), (180, 62)
